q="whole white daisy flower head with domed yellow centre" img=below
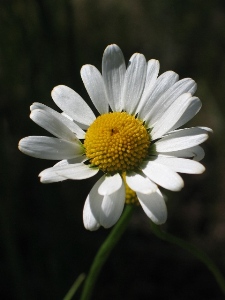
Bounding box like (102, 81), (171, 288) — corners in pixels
(19, 45), (210, 230)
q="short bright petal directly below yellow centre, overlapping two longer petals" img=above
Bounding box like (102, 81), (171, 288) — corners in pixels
(98, 173), (122, 196)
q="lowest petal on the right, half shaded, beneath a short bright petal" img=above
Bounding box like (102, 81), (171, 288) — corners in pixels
(137, 189), (167, 225)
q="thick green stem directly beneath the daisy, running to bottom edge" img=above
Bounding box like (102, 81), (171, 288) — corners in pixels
(80, 205), (135, 300)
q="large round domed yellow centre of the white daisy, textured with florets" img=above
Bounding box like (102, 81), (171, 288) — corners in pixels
(84, 112), (150, 173)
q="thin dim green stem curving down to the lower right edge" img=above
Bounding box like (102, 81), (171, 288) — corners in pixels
(151, 222), (225, 294)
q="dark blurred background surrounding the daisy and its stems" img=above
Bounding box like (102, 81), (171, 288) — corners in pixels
(0, 0), (225, 300)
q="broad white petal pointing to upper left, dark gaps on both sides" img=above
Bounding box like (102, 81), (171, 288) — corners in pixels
(52, 85), (95, 125)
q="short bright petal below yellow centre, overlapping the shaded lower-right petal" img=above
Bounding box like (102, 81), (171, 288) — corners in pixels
(126, 172), (157, 194)
